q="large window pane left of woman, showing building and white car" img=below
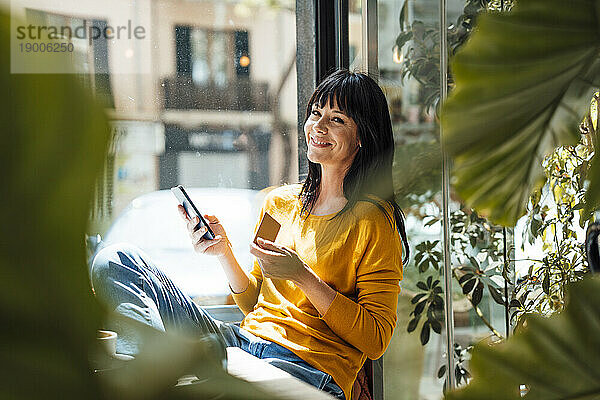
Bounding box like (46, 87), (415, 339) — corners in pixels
(15, 0), (298, 304)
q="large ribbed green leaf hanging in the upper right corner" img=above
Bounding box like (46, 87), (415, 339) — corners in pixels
(442, 0), (600, 226)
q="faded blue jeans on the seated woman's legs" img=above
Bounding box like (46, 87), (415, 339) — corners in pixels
(91, 244), (345, 399)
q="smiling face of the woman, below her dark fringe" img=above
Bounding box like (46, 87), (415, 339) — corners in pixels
(304, 102), (359, 168)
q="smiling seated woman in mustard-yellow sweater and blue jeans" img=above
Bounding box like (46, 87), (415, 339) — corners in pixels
(92, 70), (408, 399)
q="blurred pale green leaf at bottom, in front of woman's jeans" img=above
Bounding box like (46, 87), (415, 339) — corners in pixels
(99, 315), (276, 400)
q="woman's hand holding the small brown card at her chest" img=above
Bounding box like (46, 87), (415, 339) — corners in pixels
(250, 238), (310, 283)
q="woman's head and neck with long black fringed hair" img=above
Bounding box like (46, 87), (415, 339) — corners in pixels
(301, 70), (409, 262)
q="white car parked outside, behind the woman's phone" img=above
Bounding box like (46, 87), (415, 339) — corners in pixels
(94, 188), (264, 305)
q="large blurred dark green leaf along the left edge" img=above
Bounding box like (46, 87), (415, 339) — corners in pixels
(0, 12), (108, 399)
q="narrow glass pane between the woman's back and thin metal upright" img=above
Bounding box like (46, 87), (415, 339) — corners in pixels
(372, 0), (446, 399)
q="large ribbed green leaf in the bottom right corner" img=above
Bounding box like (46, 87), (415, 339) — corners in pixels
(446, 277), (600, 400)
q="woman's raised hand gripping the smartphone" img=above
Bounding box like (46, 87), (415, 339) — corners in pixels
(177, 205), (230, 256)
